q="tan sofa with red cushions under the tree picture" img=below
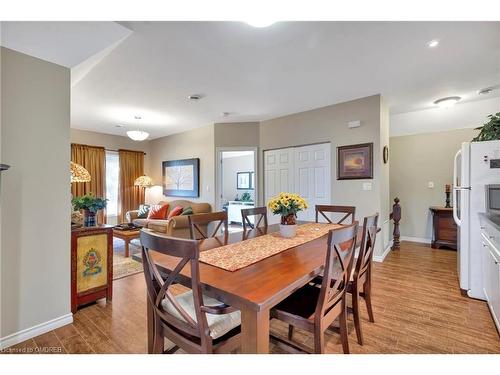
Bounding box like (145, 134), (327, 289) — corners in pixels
(125, 199), (212, 238)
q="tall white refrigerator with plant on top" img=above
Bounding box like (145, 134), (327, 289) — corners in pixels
(453, 141), (500, 300)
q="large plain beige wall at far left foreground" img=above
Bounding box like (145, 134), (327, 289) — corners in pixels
(0, 48), (71, 345)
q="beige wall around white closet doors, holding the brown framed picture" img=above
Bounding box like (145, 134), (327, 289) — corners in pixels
(259, 95), (389, 258)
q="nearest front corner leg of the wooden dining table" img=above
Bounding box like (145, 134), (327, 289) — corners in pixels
(241, 309), (269, 354)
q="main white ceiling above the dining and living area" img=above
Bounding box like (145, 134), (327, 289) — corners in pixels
(0, 22), (500, 138)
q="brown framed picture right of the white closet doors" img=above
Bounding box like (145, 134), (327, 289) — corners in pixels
(337, 143), (373, 180)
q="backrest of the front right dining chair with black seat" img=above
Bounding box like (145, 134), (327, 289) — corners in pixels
(315, 222), (358, 319)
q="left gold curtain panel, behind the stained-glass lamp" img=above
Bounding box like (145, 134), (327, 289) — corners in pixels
(71, 143), (106, 224)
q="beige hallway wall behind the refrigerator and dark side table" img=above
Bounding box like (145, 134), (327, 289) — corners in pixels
(390, 129), (477, 240)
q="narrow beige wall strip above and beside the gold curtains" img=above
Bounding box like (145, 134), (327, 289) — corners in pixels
(70, 129), (151, 175)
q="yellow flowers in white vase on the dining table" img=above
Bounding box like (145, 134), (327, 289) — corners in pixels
(267, 193), (307, 238)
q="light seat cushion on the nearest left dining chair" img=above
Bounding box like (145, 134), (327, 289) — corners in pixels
(161, 290), (241, 340)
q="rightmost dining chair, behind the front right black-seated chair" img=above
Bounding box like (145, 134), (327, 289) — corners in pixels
(347, 213), (379, 345)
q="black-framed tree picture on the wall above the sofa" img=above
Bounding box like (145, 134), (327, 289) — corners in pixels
(162, 158), (200, 198)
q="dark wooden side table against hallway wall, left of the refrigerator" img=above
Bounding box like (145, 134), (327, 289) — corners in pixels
(430, 207), (457, 250)
